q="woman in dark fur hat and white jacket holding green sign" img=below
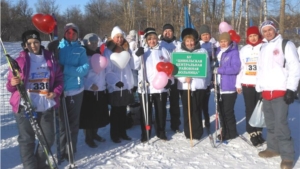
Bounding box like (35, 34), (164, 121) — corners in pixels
(176, 28), (211, 140)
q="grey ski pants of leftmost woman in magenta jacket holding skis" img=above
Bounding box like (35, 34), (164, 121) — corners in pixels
(15, 106), (55, 169)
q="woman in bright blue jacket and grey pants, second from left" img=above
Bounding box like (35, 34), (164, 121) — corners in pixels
(58, 23), (90, 160)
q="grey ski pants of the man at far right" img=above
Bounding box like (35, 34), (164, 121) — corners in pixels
(262, 97), (295, 161)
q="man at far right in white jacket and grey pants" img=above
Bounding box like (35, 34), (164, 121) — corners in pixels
(255, 20), (300, 169)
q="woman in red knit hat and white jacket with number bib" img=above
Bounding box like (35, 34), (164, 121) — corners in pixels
(235, 26), (265, 146)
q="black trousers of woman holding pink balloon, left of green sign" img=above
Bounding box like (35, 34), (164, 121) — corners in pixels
(139, 92), (168, 137)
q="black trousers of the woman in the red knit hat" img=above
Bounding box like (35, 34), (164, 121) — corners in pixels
(242, 86), (262, 134)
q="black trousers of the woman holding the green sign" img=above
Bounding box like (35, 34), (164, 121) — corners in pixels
(179, 89), (205, 139)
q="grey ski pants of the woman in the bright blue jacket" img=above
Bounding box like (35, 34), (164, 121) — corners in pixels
(60, 92), (83, 156)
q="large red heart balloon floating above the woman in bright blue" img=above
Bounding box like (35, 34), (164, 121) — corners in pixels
(31, 14), (56, 34)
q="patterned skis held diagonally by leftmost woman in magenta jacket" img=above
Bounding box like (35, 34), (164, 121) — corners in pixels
(1, 52), (58, 169)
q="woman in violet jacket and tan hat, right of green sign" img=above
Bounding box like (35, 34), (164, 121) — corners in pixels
(213, 32), (241, 140)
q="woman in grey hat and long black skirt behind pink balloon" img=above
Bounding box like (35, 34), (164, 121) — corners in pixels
(79, 33), (109, 148)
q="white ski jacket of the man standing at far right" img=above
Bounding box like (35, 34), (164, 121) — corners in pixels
(256, 35), (300, 92)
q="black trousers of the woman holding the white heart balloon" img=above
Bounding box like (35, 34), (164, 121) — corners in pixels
(110, 106), (127, 140)
